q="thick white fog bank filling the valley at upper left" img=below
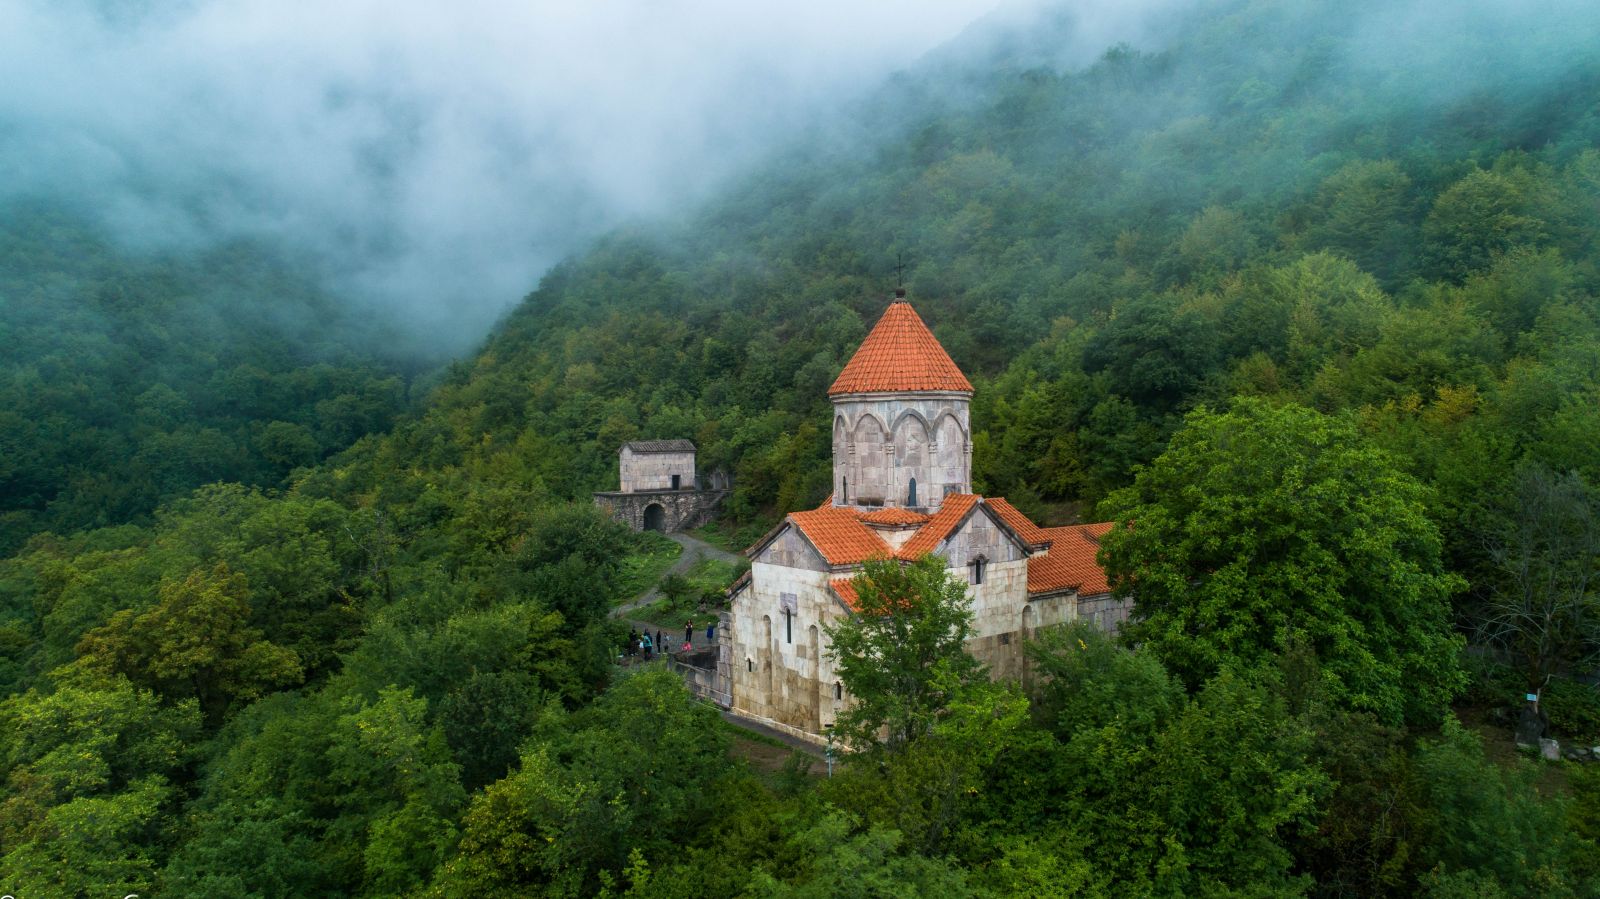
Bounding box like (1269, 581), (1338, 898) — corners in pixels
(0, 0), (1017, 352)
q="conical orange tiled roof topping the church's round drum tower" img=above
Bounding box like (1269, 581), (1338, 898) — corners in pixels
(827, 301), (973, 397)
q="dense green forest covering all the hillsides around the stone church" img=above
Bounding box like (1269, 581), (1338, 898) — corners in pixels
(0, 0), (1600, 897)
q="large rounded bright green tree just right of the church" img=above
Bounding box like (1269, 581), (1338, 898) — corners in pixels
(1101, 400), (1462, 723)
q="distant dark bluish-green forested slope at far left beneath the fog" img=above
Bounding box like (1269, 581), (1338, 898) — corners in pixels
(0, 202), (414, 553)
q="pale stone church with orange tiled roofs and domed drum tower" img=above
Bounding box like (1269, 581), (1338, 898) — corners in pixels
(717, 291), (1131, 741)
